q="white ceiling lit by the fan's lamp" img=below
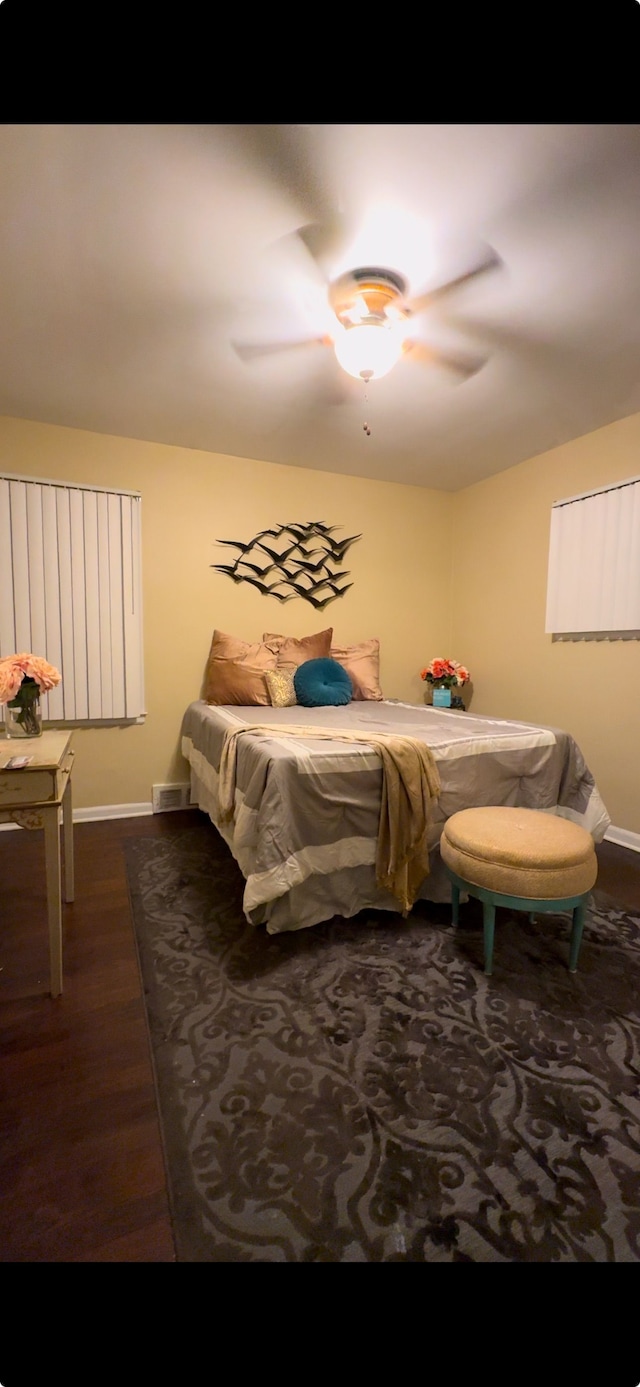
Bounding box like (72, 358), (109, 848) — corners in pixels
(0, 123), (640, 491)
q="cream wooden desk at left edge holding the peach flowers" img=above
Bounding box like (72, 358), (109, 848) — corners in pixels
(0, 731), (75, 997)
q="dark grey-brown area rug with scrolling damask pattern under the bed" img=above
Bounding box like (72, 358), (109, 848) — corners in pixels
(125, 817), (640, 1262)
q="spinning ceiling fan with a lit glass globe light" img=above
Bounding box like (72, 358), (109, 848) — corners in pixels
(233, 244), (501, 383)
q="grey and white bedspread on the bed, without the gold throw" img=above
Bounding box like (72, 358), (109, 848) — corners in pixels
(182, 699), (611, 933)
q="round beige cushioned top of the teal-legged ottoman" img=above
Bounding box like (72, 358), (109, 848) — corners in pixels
(440, 806), (598, 900)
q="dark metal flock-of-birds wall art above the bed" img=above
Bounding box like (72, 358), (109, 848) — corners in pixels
(211, 520), (362, 612)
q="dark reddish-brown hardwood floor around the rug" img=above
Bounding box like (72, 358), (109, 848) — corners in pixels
(0, 810), (640, 1262)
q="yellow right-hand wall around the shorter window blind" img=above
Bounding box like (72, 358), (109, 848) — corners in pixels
(451, 415), (640, 834)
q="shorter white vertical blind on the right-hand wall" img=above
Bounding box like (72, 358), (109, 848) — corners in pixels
(546, 477), (640, 635)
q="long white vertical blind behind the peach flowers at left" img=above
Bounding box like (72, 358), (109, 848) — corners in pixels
(0, 473), (144, 723)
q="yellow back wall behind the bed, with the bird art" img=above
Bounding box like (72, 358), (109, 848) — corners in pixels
(0, 417), (454, 807)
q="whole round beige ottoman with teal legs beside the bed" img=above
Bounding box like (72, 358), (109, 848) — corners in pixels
(440, 806), (598, 974)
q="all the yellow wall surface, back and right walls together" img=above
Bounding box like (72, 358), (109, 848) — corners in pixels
(0, 415), (640, 834)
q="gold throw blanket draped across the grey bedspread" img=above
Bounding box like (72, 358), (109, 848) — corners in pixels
(219, 723), (440, 914)
